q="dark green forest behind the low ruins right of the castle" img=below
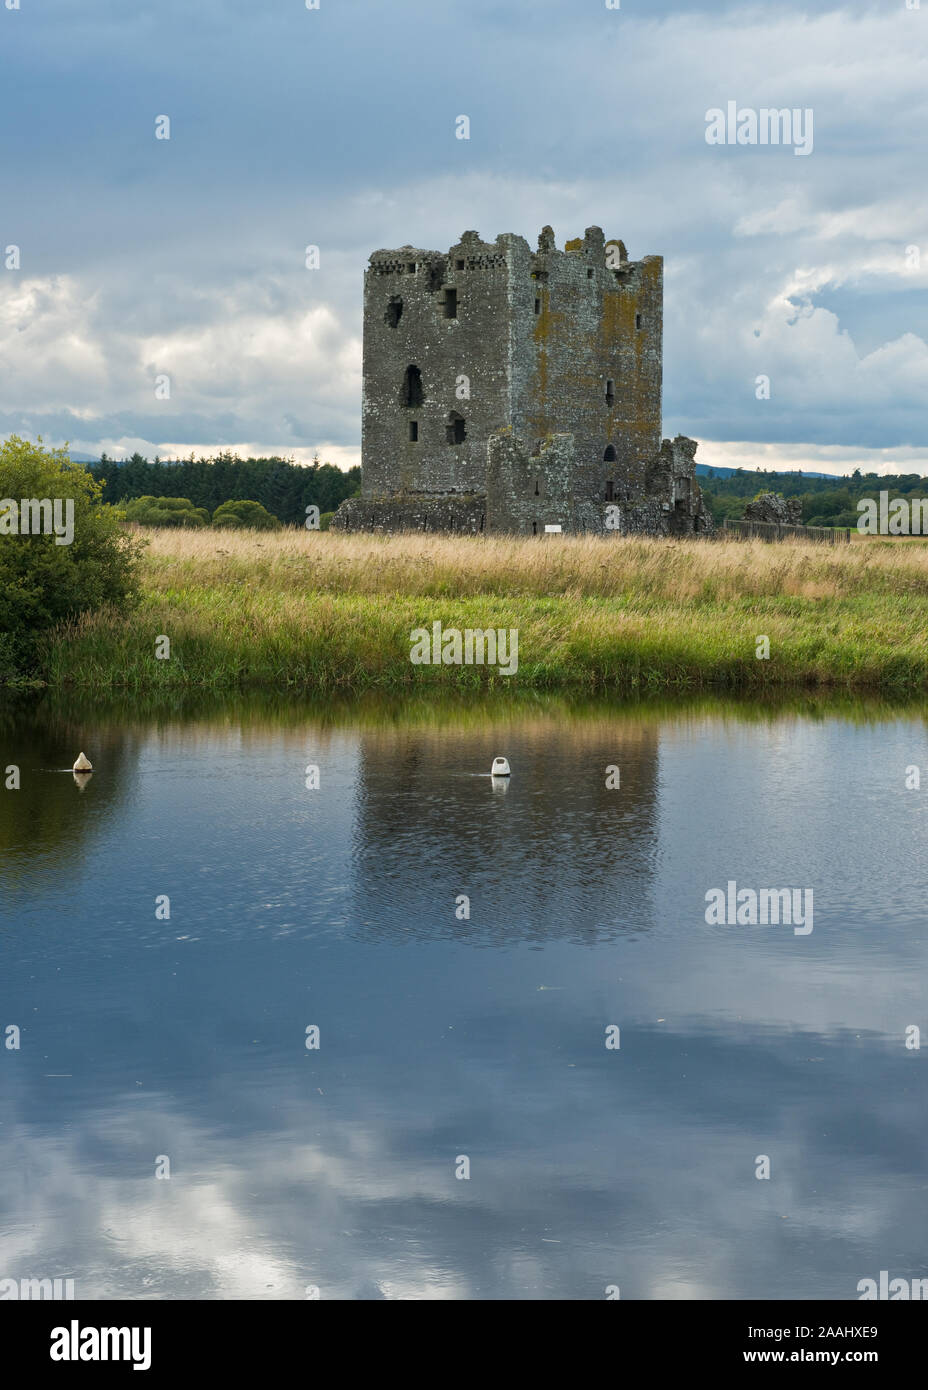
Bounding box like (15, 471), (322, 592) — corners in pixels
(697, 468), (928, 527)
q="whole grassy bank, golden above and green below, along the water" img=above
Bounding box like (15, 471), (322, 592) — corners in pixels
(44, 531), (928, 694)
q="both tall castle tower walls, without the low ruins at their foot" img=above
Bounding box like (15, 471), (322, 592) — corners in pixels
(361, 227), (663, 511)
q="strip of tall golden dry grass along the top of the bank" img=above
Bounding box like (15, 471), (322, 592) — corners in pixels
(142, 530), (928, 602)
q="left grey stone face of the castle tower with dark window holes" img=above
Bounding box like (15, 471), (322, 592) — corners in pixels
(361, 232), (514, 498)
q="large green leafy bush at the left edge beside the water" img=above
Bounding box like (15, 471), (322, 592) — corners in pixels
(0, 435), (140, 682)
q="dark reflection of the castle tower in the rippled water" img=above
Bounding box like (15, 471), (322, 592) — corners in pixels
(345, 713), (658, 944)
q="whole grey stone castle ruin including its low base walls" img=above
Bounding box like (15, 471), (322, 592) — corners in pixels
(332, 227), (711, 535)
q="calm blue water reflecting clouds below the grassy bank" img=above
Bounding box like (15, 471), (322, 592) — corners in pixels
(0, 702), (928, 1300)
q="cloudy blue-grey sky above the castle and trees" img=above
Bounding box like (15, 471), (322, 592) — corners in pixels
(0, 0), (928, 474)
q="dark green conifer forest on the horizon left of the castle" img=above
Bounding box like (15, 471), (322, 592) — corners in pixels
(88, 453), (361, 525)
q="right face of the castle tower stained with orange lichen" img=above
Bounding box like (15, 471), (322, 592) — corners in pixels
(513, 227), (663, 499)
